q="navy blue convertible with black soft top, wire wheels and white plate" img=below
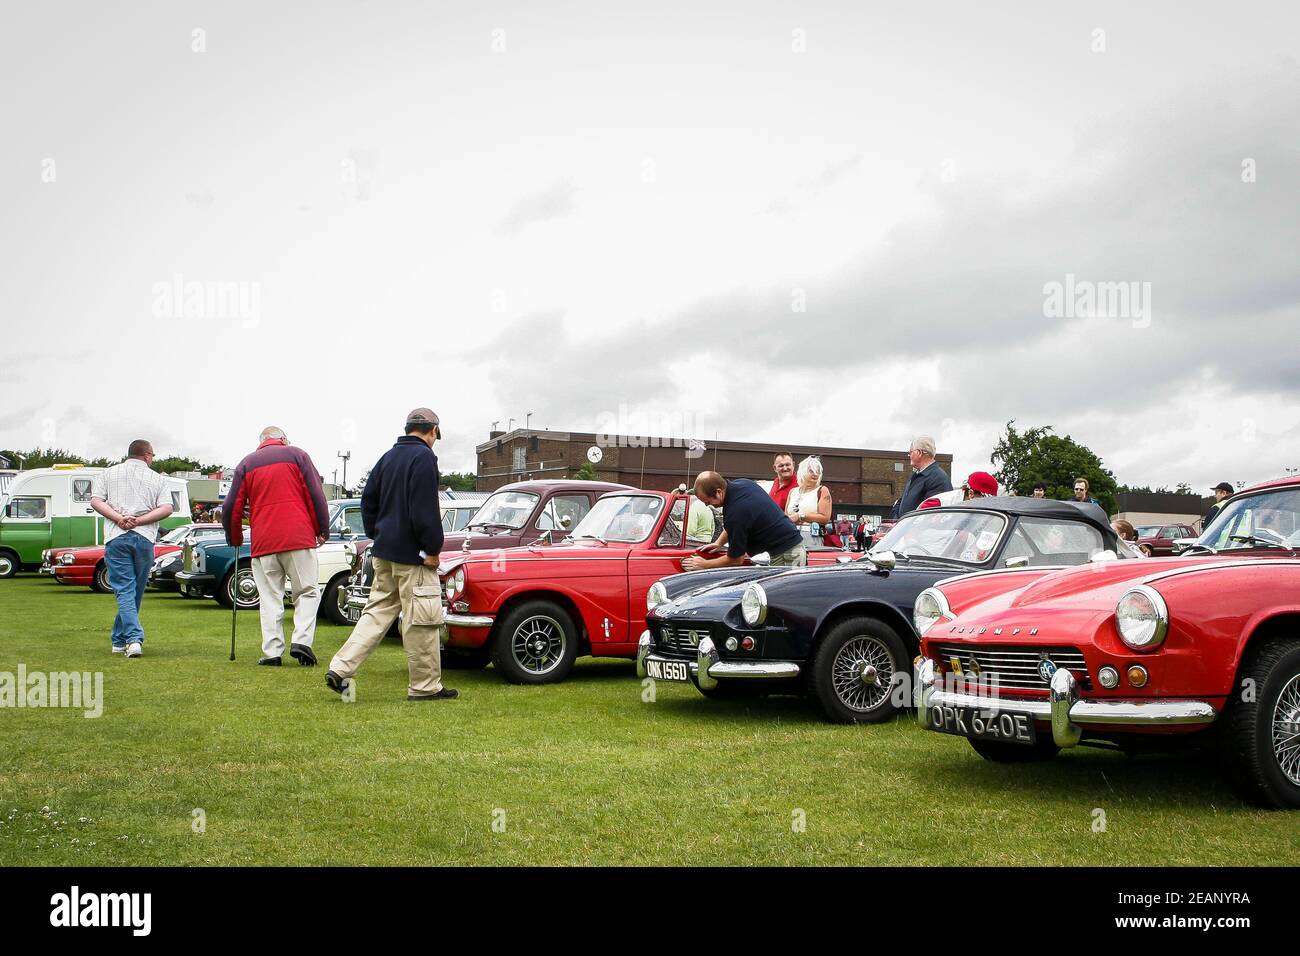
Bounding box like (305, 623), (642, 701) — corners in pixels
(637, 498), (1131, 723)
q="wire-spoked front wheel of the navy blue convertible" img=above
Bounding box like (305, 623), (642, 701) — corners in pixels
(807, 615), (910, 723)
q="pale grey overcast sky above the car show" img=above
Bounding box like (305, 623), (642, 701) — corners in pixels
(0, 0), (1300, 490)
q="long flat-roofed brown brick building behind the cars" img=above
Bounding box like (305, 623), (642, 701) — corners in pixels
(476, 428), (953, 516)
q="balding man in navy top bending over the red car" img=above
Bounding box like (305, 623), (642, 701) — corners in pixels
(681, 471), (807, 571)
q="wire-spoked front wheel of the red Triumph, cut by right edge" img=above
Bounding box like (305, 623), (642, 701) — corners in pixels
(1219, 640), (1300, 809)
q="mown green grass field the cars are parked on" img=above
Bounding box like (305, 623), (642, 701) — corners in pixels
(0, 576), (1300, 866)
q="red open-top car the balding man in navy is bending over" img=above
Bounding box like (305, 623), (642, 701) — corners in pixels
(439, 490), (707, 684)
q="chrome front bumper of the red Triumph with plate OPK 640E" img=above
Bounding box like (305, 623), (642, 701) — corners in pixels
(913, 658), (1218, 747)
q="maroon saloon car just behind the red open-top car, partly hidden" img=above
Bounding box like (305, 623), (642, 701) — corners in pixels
(337, 480), (633, 623)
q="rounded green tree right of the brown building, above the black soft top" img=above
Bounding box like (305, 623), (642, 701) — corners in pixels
(992, 419), (1117, 514)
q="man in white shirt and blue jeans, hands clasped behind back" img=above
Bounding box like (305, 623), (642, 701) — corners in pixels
(90, 438), (172, 657)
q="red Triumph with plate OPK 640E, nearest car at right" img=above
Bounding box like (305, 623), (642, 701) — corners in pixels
(914, 477), (1300, 808)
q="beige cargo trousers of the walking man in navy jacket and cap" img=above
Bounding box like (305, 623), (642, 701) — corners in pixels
(329, 558), (442, 697)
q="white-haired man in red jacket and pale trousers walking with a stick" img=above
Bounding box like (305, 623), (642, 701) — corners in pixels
(221, 425), (329, 667)
